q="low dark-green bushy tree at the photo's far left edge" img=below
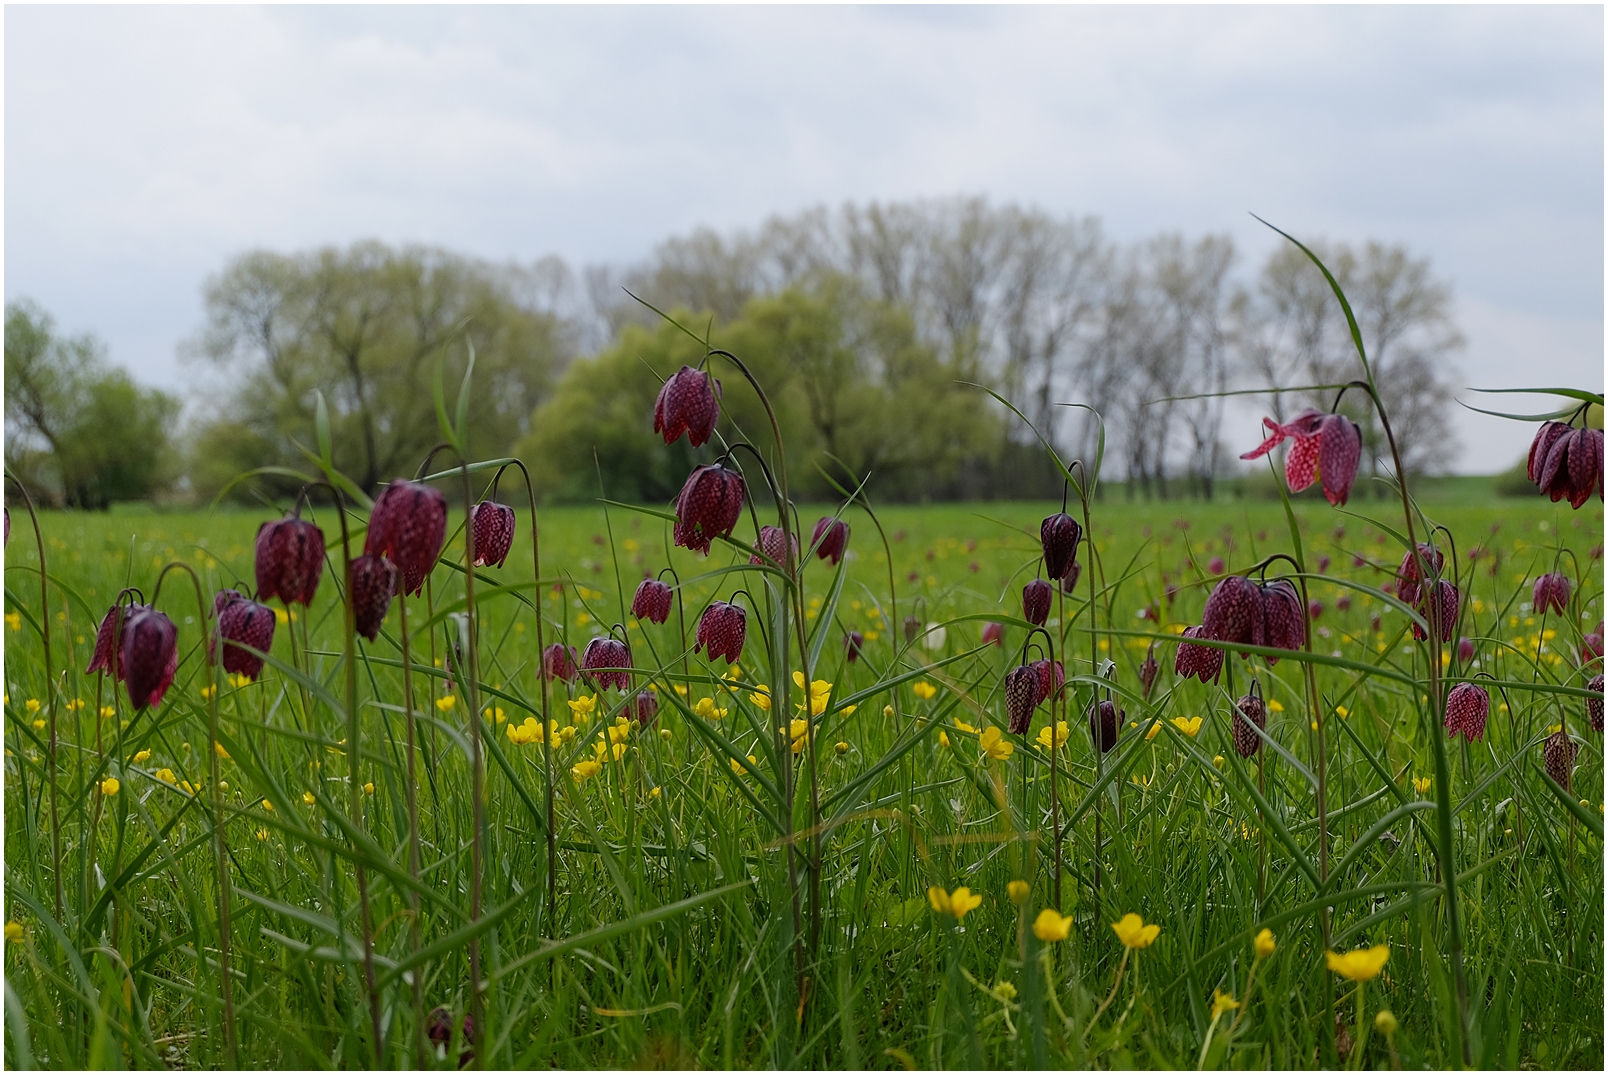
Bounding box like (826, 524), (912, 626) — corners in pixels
(5, 299), (178, 509)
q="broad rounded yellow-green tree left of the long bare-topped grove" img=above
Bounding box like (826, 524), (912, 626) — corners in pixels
(191, 243), (572, 493)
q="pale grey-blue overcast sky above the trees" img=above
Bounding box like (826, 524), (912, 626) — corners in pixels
(5, 6), (1603, 471)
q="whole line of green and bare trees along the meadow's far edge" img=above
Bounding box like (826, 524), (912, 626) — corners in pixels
(6, 198), (1463, 506)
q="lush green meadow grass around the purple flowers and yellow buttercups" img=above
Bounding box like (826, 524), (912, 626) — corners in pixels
(5, 484), (1603, 1069)
